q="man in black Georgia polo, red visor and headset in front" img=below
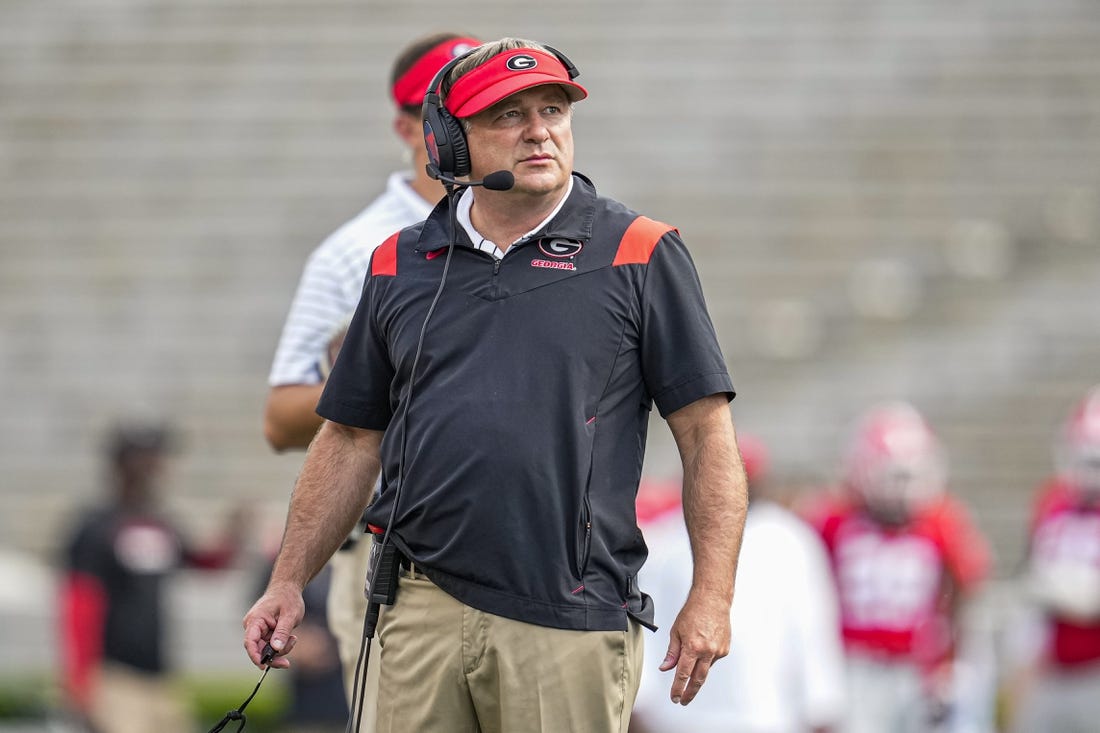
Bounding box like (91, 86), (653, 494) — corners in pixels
(244, 39), (746, 733)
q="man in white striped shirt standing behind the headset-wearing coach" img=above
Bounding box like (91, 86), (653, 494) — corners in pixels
(264, 32), (481, 713)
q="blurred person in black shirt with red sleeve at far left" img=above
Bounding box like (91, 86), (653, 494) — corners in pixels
(58, 423), (240, 733)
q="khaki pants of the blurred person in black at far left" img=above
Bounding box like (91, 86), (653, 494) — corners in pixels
(91, 663), (195, 733)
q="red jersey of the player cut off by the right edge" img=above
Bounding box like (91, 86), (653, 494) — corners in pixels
(1031, 479), (1100, 667)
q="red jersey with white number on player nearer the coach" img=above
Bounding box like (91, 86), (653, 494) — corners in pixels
(807, 488), (990, 666)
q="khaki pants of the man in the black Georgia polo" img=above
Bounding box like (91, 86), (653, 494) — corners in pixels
(374, 571), (644, 733)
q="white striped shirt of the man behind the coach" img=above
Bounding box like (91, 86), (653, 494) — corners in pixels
(267, 173), (432, 386)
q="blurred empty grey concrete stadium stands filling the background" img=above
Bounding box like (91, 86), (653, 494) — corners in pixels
(0, 0), (1100, 567)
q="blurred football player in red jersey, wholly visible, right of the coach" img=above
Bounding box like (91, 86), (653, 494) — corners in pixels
(806, 402), (990, 733)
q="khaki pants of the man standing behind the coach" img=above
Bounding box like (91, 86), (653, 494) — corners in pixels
(327, 533), (382, 733)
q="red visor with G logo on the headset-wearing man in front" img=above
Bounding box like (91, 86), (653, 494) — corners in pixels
(444, 48), (589, 118)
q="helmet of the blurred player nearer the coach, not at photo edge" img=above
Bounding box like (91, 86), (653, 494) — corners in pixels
(844, 402), (946, 523)
